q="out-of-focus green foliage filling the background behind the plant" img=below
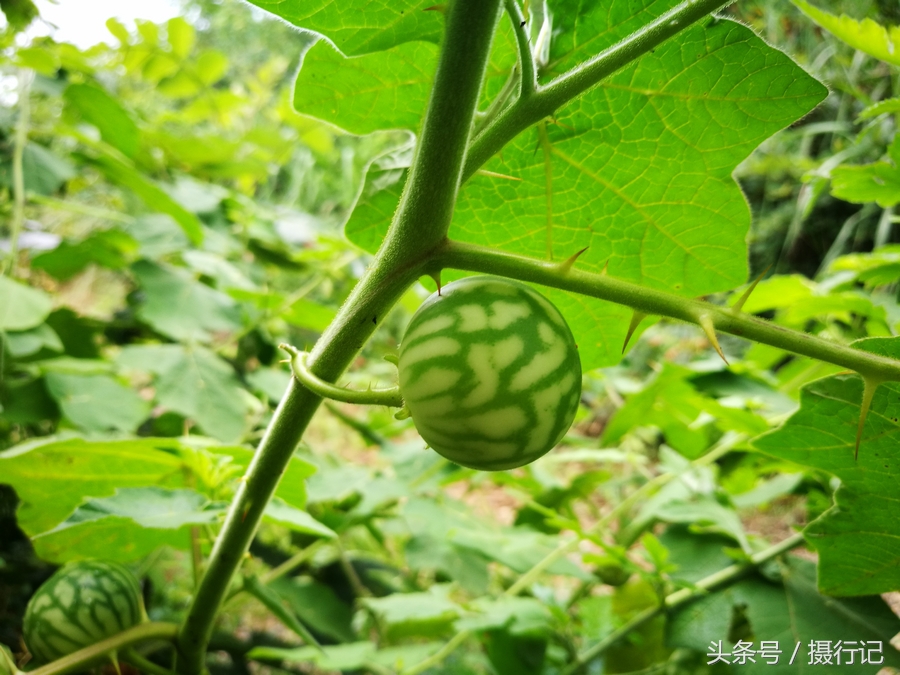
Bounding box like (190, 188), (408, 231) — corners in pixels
(0, 0), (900, 675)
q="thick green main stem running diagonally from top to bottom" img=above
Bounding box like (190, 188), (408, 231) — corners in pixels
(177, 0), (500, 675)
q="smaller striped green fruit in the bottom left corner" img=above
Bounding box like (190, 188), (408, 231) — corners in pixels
(23, 560), (145, 663)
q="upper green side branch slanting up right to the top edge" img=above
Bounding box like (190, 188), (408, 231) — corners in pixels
(463, 0), (733, 180)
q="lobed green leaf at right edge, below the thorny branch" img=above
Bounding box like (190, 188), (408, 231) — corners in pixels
(754, 338), (900, 595)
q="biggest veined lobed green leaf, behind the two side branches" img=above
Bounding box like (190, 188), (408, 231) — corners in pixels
(346, 17), (826, 368)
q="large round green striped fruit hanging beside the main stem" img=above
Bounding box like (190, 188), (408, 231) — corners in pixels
(398, 277), (581, 471)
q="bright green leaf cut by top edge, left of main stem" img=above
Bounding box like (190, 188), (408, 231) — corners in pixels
(244, 0), (444, 56)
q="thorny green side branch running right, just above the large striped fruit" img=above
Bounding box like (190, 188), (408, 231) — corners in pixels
(433, 242), (900, 381)
